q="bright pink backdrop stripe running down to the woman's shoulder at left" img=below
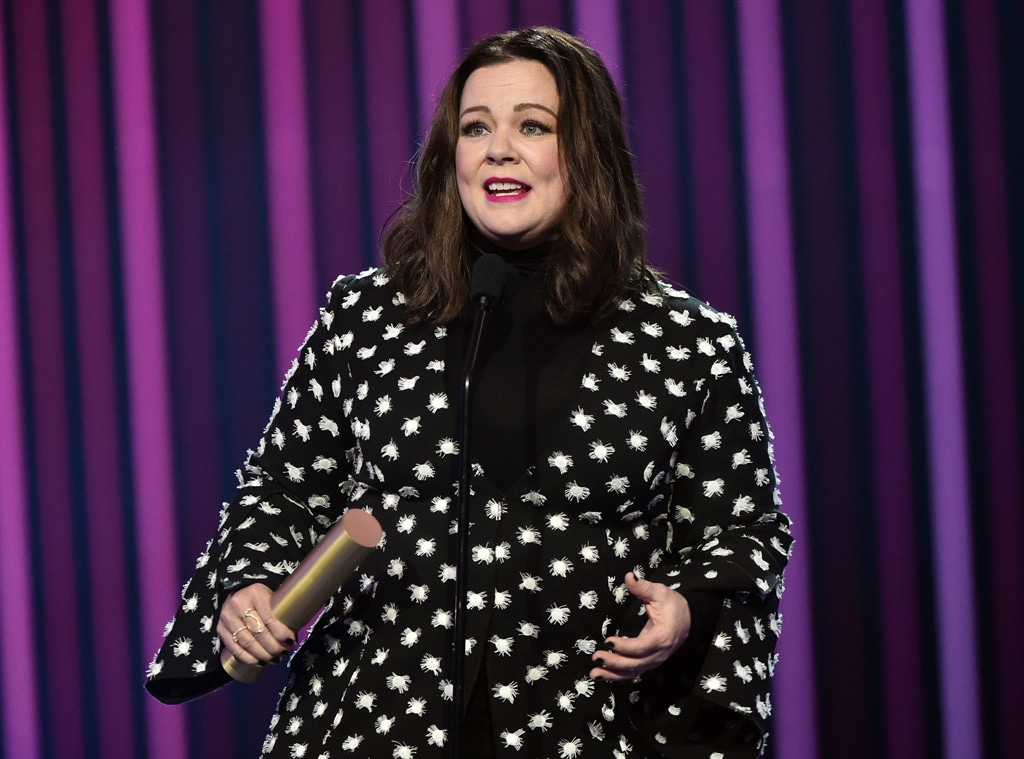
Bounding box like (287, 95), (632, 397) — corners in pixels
(259, 0), (318, 373)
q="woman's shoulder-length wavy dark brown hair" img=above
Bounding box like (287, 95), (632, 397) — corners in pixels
(381, 27), (657, 326)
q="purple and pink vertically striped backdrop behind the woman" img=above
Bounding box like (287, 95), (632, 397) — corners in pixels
(0, 0), (1024, 759)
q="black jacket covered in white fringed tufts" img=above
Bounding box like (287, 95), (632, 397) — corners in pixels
(146, 269), (791, 759)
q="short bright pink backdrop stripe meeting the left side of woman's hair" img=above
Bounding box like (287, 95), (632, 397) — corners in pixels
(413, 0), (461, 139)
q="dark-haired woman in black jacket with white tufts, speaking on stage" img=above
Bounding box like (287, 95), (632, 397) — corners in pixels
(147, 29), (791, 759)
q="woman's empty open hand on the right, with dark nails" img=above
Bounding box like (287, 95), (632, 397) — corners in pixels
(590, 572), (690, 681)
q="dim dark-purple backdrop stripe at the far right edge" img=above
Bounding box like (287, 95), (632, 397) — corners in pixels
(963, 0), (1024, 747)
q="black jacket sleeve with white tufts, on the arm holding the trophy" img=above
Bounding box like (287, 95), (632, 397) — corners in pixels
(145, 280), (360, 704)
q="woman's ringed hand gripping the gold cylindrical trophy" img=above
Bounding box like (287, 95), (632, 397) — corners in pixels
(217, 583), (295, 666)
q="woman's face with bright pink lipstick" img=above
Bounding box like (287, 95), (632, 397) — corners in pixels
(455, 60), (565, 250)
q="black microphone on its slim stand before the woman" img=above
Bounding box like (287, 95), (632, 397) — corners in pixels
(449, 253), (508, 759)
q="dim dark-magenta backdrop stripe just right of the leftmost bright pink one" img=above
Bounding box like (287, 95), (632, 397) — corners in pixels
(11, 3), (85, 756)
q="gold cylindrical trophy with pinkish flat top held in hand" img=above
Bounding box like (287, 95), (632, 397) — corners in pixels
(220, 509), (383, 682)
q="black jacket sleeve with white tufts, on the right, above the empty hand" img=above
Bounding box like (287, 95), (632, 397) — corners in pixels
(626, 313), (792, 759)
